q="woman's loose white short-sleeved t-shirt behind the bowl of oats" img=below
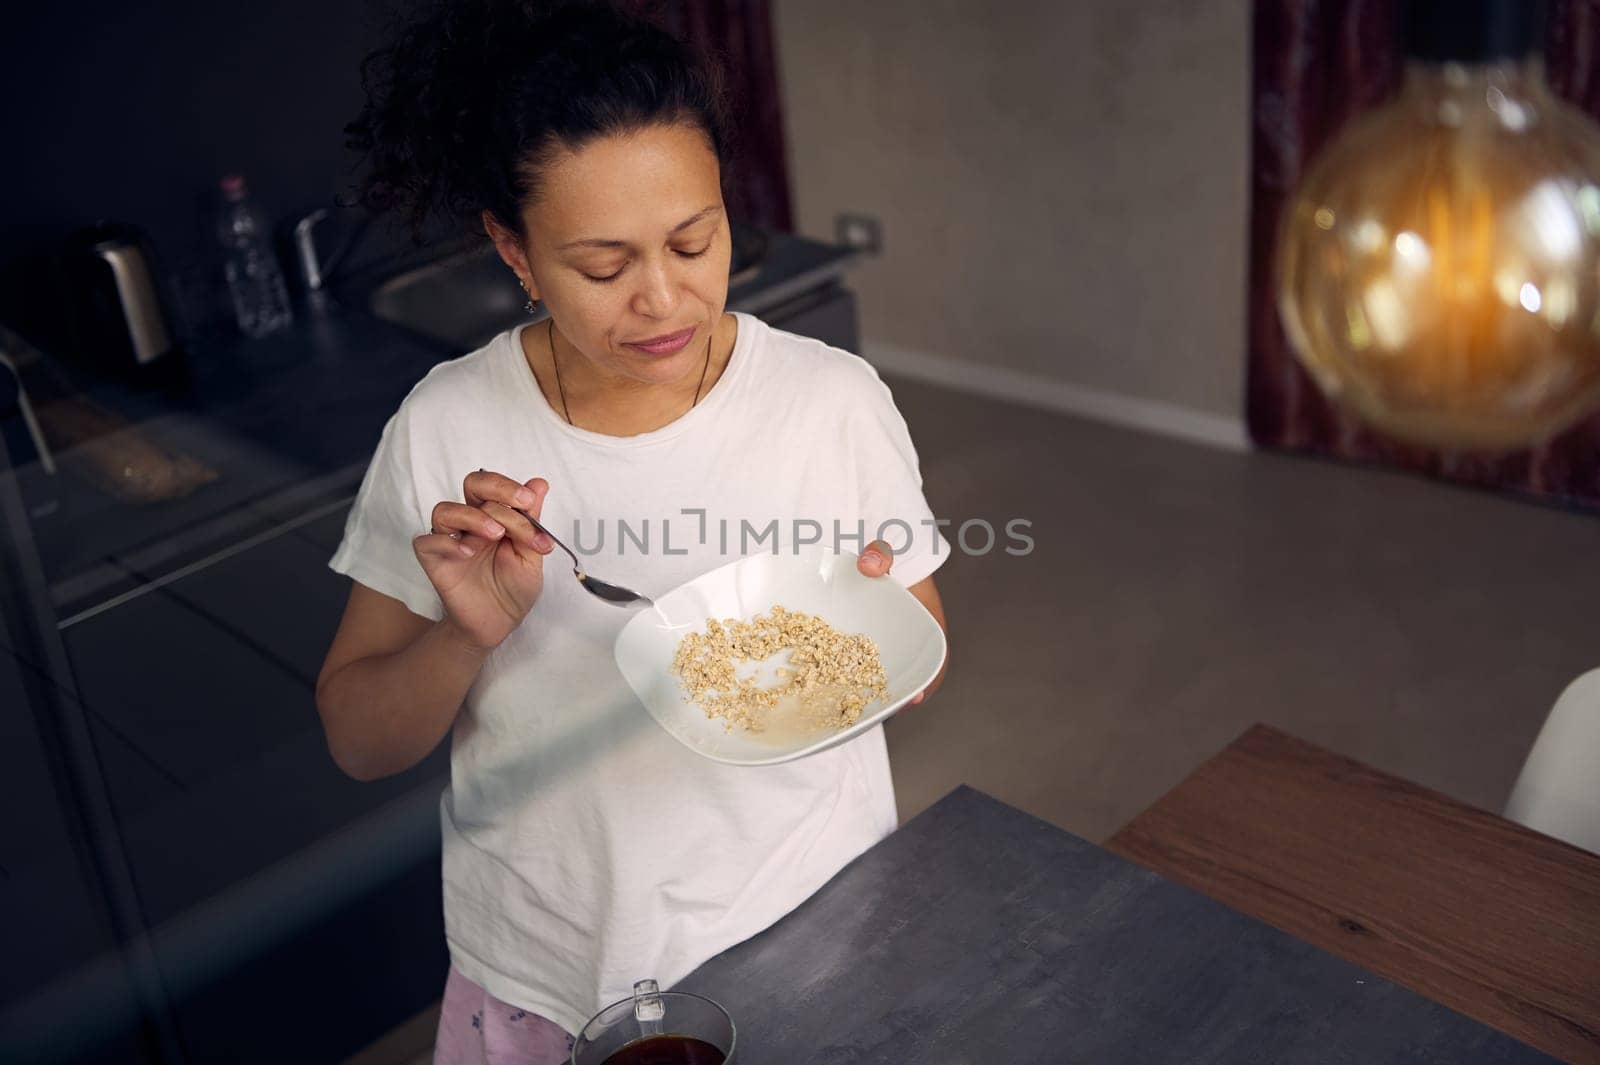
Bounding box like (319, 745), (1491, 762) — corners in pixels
(330, 313), (950, 1031)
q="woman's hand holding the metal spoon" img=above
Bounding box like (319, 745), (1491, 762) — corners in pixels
(411, 470), (555, 651)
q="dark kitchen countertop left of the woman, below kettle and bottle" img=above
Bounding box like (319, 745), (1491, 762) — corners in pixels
(18, 294), (448, 616)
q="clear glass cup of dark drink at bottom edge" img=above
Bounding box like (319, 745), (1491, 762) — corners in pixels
(571, 980), (734, 1065)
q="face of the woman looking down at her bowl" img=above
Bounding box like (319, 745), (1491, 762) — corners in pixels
(490, 125), (733, 385)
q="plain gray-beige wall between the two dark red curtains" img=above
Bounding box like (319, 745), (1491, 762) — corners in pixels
(776, 0), (1250, 417)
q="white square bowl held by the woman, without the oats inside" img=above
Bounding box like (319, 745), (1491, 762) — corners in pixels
(614, 547), (946, 766)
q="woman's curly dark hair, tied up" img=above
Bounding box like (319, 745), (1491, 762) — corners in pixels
(344, 0), (731, 243)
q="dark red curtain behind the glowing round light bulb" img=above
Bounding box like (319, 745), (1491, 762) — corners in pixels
(1246, 0), (1600, 509)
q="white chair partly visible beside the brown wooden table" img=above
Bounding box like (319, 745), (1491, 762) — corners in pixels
(1506, 670), (1600, 854)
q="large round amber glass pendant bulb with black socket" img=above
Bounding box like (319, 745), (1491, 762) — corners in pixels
(1275, 0), (1600, 451)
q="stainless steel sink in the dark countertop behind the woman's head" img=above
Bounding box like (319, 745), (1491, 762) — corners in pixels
(348, 225), (766, 352)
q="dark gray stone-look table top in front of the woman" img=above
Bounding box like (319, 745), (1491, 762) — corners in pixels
(677, 787), (1554, 1065)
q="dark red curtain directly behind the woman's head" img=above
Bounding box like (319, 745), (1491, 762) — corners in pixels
(634, 0), (794, 232)
